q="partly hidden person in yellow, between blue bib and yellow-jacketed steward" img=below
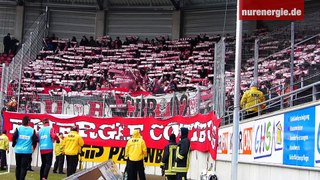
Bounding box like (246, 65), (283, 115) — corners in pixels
(53, 132), (65, 174)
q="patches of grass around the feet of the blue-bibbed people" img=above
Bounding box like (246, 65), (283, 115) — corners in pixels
(0, 168), (67, 180)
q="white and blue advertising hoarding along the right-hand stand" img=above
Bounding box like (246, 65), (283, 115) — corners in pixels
(217, 106), (320, 167)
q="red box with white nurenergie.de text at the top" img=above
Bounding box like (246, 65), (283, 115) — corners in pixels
(239, 0), (304, 20)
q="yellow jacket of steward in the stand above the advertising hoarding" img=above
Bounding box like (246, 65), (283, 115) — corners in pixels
(240, 86), (266, 112)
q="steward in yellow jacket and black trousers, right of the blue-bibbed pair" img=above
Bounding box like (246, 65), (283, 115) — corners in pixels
(63, 126), (84, 176)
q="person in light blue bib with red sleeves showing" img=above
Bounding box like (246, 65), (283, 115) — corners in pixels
(39, 118), (59, 180)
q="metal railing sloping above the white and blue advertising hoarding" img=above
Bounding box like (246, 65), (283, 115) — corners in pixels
(222, 81), (320, 125)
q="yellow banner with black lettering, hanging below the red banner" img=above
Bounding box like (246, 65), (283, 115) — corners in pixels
(80, 145), (163, 166)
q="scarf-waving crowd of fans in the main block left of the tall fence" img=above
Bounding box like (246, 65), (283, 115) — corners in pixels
(22, 35), (220, 97)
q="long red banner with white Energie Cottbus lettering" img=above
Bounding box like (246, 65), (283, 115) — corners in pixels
(4, 112), (220, 159)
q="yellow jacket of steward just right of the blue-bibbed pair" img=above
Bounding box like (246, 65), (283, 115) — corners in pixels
(63, 131), (84, 155)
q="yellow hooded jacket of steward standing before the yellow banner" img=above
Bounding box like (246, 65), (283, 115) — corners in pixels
(125, 130), (147, 161)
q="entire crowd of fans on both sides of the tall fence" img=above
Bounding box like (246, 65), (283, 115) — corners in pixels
(2, 25), (320, 115)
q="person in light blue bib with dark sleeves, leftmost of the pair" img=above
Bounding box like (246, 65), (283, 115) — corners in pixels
(12, 116), (39, 180)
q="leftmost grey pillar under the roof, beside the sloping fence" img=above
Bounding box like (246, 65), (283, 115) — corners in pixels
(14, 6), (24, 42)
